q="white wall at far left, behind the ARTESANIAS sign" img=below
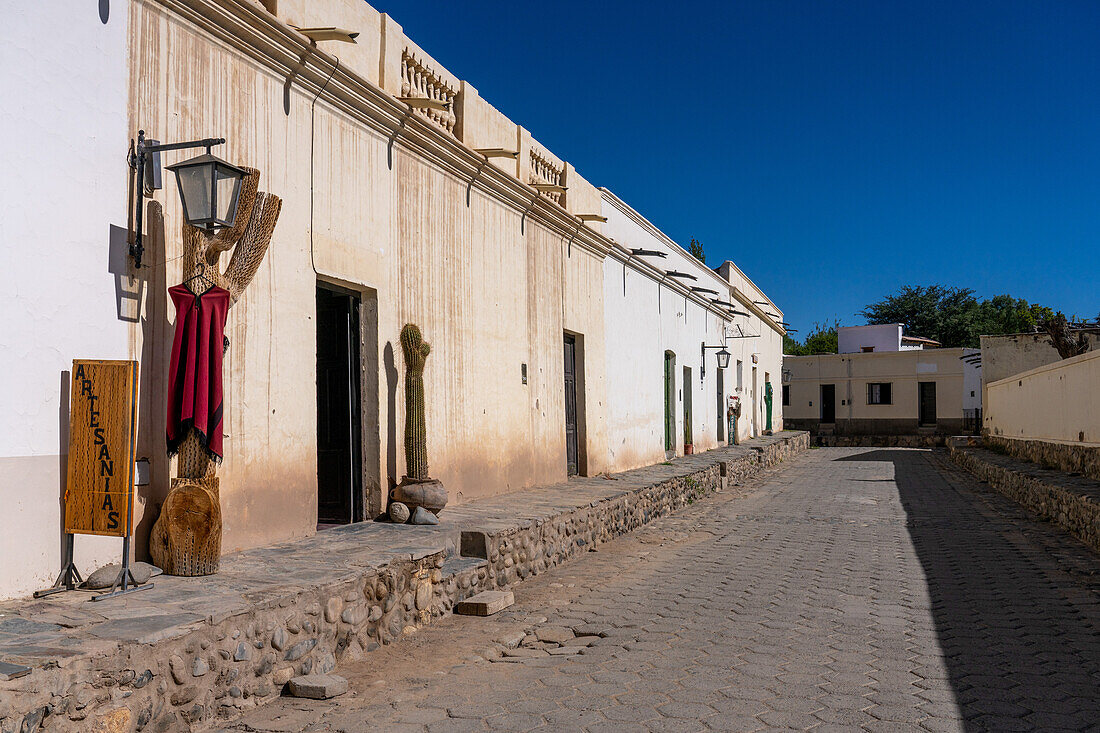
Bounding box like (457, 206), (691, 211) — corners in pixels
(0, 1), (129, 597)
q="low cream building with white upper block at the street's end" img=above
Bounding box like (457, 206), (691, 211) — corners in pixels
(782, 324), (981, 436)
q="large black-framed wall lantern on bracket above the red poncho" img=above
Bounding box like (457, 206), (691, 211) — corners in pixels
(130, 130), (246, 269)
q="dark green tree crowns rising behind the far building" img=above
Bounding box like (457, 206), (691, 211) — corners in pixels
(859, 285), (1054, 347)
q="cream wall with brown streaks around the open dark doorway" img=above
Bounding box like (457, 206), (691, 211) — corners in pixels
(131, 2), (620, 551)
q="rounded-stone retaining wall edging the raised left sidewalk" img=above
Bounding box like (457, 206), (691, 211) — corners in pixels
(0, 433), (809, 733)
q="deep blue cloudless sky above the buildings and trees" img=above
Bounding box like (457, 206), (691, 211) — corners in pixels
(374, 0), (1100, 337)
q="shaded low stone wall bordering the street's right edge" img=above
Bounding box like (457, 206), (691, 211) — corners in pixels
(948, 446), (1100, 551)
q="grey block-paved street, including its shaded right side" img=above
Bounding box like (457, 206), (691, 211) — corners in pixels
(230, 448), (1100, 733)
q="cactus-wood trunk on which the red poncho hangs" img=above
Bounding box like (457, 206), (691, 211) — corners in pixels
(150, 168), (283, 576)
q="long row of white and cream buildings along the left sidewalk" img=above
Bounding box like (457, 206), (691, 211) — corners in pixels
(0, 0), (783, 598)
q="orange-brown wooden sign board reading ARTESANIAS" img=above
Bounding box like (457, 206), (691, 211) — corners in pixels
(65, 359), (138, 537)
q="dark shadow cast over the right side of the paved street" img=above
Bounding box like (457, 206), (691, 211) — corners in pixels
(836, 450), (1100, 731)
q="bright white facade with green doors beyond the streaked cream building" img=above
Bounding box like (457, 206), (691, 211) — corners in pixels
(601, 188), (782, 470)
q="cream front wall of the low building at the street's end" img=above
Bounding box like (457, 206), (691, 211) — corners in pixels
(783, 349), (964, 420)
